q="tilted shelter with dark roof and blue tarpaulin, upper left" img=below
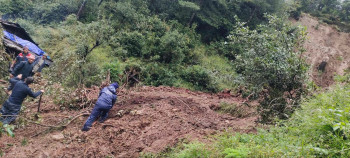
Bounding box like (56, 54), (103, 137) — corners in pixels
(0, 20), (52, 65)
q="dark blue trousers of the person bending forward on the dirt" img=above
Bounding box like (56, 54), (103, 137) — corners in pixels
(83, 104), (112, 131)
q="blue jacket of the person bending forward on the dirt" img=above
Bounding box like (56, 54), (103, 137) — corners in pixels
(96, 86), (117, 108)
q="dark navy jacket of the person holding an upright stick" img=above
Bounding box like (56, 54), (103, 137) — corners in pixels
(8, 77), (41, 105)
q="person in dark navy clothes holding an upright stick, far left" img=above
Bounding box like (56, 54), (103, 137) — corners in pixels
(0, 75), (44, 124)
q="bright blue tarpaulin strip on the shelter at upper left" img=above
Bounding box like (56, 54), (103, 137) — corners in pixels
(4, 31), (45, 56)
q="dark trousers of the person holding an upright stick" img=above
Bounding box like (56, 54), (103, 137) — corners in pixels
(0, 100), (21, 124)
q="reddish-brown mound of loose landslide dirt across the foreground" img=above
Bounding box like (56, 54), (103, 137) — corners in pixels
(0, 87), (257, 157)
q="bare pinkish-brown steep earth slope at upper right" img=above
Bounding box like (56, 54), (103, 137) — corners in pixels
(296, 14), (350, 87)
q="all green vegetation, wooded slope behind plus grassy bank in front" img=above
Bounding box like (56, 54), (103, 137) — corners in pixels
(0, 0), (350, 157)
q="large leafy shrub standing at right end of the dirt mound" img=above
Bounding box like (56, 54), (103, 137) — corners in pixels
(229, 16), (307, 122)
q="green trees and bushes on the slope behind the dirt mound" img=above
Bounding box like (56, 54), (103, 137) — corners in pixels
(0, 0), (305, 116)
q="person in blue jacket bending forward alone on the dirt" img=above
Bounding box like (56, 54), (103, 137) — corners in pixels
(81, 82), (119, 131)
